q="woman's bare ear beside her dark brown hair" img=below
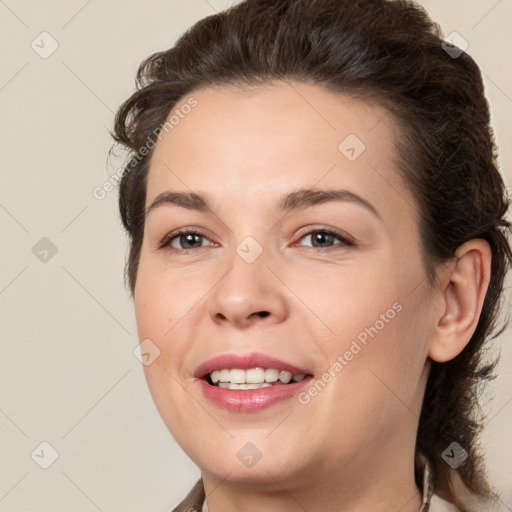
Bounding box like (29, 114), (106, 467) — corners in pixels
(428, 238), (491, 363)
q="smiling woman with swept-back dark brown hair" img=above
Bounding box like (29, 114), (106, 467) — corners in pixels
(110, 0), (512, 512)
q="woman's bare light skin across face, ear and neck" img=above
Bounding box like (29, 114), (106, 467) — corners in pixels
(134, 82), (490, 512)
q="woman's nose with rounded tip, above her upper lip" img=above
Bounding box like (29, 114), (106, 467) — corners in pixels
(209, 248), (288, 328)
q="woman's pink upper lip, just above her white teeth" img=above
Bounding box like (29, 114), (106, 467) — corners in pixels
(194, 352), (311, 379)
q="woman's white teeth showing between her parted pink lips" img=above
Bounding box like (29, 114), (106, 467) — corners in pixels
(210, 368), (306, 389)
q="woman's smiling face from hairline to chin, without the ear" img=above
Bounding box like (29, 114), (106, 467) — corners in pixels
(134, 82), (433, 488)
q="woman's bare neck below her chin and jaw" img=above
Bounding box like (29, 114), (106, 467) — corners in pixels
(203, 430), (422, 512)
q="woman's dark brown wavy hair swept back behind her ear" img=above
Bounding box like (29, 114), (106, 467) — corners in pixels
(113, 0), (512, 510)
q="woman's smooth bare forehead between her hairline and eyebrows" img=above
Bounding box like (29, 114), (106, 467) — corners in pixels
(146, 82), (414, 224)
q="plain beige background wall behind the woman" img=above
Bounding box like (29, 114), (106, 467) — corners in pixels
(0, 0), (512, 512)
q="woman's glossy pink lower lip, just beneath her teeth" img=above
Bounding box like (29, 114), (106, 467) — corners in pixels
(198, 377), (312, 412)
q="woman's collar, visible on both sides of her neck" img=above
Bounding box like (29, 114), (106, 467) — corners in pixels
(172, 464), (459, 512)
